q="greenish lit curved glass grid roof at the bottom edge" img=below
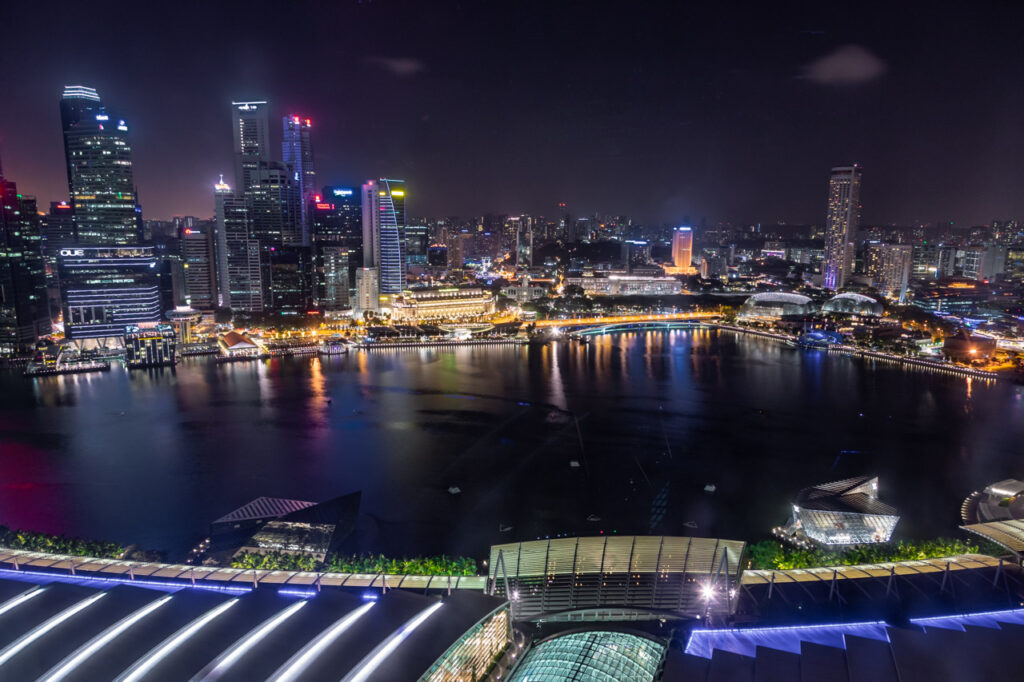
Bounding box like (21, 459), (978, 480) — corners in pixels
(509, 630), (665, 682)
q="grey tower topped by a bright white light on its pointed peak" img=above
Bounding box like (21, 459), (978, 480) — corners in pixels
(214, 176), (263, 312)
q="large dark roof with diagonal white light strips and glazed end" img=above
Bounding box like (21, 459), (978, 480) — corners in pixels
(0, 577), (510, 681)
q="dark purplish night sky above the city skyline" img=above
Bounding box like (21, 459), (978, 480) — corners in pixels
(0, 0), (1024, 224)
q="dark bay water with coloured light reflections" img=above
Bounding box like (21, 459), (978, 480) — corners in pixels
(0, 331), (1024, 558)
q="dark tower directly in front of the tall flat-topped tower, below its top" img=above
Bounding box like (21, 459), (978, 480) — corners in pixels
(245, 161), (303, 249)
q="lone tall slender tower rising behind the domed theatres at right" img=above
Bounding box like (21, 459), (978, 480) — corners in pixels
(823, 165), (860, 290)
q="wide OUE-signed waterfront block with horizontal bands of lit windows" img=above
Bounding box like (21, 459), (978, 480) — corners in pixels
(57, 246), (174, 345)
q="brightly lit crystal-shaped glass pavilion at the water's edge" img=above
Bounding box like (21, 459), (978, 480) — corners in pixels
(786, 476), (899, 545)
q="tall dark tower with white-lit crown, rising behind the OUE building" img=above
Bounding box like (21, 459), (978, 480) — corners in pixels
(60, 85), (141, 246)
